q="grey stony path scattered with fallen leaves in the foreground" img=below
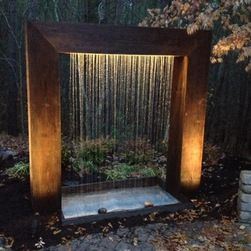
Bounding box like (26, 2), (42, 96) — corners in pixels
(44, 219), (251, 251)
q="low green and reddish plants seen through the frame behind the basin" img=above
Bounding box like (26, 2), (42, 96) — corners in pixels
(62, 138), (165, 180)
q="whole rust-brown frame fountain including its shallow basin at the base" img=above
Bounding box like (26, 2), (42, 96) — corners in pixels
(26, 23), (211, 223)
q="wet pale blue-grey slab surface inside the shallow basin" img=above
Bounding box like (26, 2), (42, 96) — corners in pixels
(62, 186), (179, 219)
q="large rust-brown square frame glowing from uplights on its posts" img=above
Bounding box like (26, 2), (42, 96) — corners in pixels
(26, 23), (211, 212)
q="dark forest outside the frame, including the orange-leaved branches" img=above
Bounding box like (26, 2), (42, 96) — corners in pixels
(0, 0), (251, 156)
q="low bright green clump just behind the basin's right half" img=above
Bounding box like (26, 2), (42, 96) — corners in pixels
(105, 163), (159, 180)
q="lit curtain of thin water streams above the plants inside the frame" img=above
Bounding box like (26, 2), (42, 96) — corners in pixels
(69, 54), (173, 144)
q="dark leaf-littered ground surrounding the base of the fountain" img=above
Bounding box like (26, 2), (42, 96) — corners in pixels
(0, 136), (251, 250)
